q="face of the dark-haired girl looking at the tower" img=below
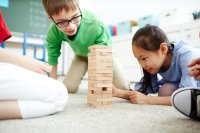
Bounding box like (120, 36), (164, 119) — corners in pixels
(132, 45), (168, 74)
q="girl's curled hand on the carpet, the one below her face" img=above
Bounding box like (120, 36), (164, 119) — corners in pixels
(129, 91), (148, 104)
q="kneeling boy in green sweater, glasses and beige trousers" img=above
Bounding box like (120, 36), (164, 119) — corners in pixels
(42, 0), (128, 93)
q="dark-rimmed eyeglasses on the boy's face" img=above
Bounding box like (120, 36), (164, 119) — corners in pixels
(51, 11), (82, 28)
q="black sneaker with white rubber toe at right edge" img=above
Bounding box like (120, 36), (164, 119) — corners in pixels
(171, 87), (200, 121)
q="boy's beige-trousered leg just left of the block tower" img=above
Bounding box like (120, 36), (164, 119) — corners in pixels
(63, 55), (88, 93)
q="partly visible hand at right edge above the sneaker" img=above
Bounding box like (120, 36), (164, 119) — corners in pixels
(188, 58), (200, 80)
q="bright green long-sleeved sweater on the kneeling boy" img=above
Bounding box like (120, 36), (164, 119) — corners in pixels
(46, 10), (112, 65)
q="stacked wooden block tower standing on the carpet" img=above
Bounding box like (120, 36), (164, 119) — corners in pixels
(87, 45), (113, 108)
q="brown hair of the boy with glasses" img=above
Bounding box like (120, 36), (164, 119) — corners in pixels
(42, 0), (79, 17)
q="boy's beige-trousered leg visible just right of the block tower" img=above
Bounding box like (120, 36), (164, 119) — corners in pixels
(113, 58), (130, 90)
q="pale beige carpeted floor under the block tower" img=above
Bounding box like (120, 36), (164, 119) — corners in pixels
(0, 80), (200, 133)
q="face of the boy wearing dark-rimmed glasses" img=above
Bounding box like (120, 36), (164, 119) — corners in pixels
(52, 9), (82, 36)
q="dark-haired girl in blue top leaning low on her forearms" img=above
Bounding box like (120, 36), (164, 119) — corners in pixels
(113, 25), (200, 105)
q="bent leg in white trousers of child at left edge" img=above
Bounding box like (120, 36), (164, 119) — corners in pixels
(0, 63), (68, 118)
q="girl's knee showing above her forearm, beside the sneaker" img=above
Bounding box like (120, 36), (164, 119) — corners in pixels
(158, 83), (177, 96)
